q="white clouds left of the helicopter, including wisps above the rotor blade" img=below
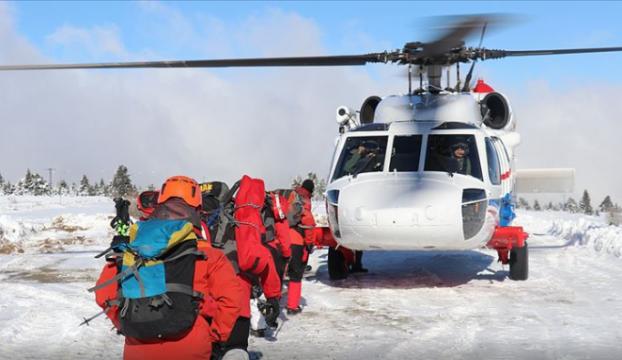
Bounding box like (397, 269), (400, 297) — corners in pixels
(0, 7), (398, 187)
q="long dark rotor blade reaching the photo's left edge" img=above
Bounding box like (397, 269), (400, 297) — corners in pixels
(0, 53), (391, 71)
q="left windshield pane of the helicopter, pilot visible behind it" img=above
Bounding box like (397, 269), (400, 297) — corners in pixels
(333, 136), (387, 180)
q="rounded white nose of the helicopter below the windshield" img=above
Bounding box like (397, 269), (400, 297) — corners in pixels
(329, 179), (486, 250)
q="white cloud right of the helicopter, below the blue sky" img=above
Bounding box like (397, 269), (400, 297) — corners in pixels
(513, 81), (622, 205)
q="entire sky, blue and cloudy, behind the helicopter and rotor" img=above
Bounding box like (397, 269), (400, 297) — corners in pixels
(0, 1), (622, 203)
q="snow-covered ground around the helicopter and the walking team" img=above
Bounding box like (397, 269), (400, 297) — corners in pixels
(0, 197), (622, 359)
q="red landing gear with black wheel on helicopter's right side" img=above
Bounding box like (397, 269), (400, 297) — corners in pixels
(488, 226), (529, 280)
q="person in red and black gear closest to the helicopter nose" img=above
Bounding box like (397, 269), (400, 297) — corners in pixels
(287, 179), (315, 315)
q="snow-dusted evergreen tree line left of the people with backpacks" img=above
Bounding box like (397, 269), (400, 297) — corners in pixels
(0, 165), (137, 197)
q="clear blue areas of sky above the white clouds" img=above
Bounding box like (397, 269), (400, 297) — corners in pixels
(13, 1), (622, 88)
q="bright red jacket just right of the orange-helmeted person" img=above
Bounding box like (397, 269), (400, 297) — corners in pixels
(234, 175), (281, 298)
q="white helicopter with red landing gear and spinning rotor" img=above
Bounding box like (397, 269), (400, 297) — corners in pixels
(0, 15), (622, 280)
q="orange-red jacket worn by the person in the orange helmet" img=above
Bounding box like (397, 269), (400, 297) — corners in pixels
(95, 240), (242, 360)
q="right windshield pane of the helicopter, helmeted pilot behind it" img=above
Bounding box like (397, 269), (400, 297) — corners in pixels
(425, 134), (484, 181)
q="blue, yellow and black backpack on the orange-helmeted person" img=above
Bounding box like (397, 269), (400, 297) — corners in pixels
(89, 219), (205, 341)
